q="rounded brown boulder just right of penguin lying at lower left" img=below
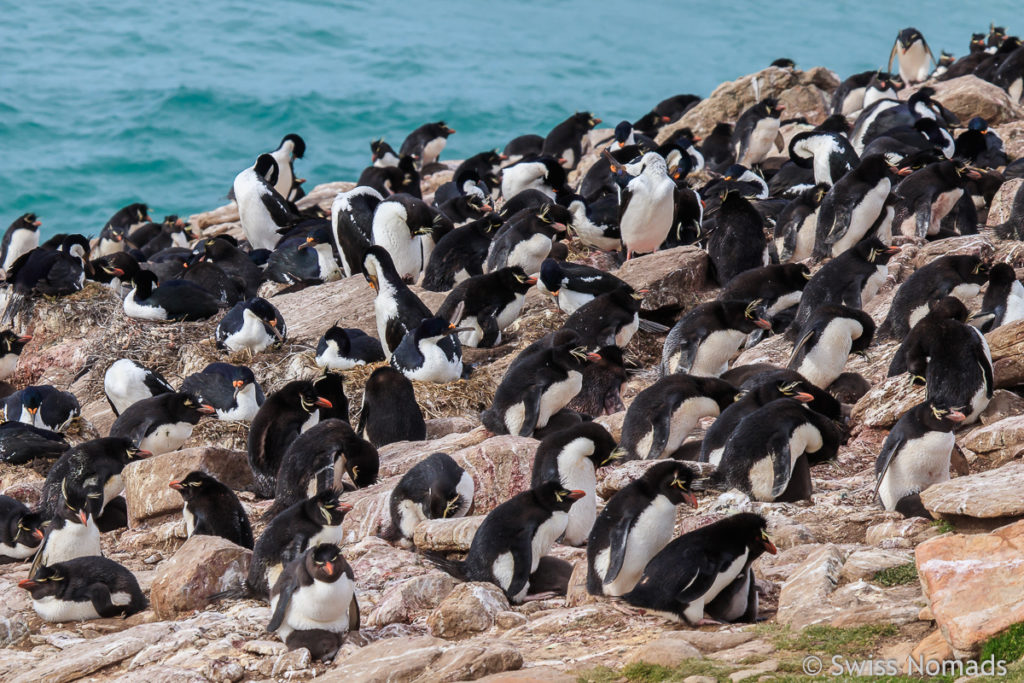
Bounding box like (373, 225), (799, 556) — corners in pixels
(150, 536), (252, 618)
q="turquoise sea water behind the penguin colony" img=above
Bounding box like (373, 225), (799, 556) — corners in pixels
(0, 0), (1024, 234)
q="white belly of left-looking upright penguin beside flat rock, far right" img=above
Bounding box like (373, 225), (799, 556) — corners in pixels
(879, 431), (956, 510)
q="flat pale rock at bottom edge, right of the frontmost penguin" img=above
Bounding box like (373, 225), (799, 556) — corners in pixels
(317, 636), (522, 683)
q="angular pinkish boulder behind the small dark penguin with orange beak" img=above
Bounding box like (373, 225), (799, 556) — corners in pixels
(123, 446), (253, 528)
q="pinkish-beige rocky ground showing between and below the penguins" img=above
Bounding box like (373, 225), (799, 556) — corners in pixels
(0, 60), (1024, 683)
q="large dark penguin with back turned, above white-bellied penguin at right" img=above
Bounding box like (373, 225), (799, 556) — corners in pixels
(889, 297), (995, 424)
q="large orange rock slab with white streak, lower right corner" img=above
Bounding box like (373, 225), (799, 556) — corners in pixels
(914, 518), (1024, 656)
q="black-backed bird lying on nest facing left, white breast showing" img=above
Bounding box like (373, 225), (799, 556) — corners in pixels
(123, 270), (220, 321)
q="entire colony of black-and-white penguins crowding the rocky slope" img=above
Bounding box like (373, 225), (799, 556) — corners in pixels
(0, 24), (1024, 660)
